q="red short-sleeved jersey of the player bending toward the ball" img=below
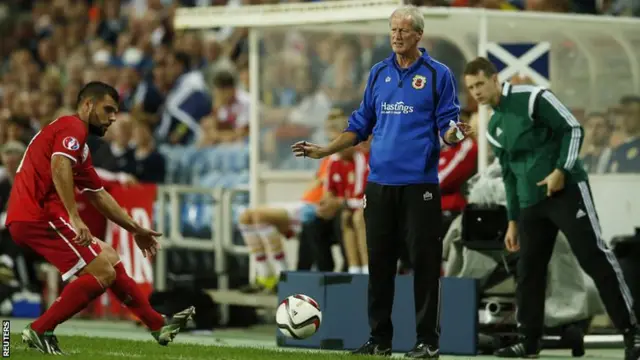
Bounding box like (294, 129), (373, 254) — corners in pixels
(7, 116), (102, 225)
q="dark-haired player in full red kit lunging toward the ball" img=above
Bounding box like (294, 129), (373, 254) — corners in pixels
(6, 82), (195, 354)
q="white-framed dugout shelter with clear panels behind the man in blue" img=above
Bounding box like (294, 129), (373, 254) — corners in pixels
(175, 0), (640, 205)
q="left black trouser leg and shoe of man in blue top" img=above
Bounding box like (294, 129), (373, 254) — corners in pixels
(354, 182), (400, 355)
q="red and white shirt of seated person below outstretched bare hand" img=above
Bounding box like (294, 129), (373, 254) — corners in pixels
(325, 151), (369, 209)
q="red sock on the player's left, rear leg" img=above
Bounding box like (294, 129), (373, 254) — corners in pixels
(31, 274), (105, 334)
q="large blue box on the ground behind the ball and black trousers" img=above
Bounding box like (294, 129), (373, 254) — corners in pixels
(276, 272), (478, 356)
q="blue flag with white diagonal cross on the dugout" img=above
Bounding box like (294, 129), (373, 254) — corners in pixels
(487, 42), (551, 88)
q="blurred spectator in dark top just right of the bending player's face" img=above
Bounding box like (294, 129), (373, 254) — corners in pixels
(133, 121), (166, 184)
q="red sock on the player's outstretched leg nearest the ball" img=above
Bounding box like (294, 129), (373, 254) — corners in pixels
(110, 263), (164, 331)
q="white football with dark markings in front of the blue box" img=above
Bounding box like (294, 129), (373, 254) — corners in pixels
(276, 294), (322, 340)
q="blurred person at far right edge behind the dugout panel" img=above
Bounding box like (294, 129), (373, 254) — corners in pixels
(609, 96), (640, 173)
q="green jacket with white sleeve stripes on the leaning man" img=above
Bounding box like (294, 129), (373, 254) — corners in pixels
(487, 83), (587, 220)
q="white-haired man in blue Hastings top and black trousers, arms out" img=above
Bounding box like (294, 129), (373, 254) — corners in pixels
(292, 6), (470, 358)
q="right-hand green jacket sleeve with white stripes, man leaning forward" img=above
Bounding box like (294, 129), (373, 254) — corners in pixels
(531, 90), (584, 172)
